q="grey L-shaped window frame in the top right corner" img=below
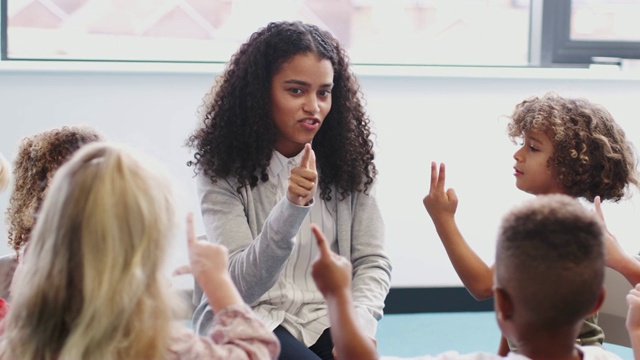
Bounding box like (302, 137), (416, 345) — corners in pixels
(529, 0), (640, 67)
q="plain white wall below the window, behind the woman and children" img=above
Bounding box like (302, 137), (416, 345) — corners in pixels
(0, 64), (640, 287)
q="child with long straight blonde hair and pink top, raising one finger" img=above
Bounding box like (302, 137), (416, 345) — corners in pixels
(0, 142), (279, 359)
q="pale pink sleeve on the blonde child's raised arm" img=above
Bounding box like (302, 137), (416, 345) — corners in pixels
(169, 304), (280, 360)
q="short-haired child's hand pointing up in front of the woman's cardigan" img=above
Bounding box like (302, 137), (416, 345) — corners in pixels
(311, 224), (352, 298)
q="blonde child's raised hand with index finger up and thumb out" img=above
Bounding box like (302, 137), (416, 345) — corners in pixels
(173, 213), (229, 283)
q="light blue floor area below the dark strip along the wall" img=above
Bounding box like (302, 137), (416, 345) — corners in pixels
(376, 311), (633, 359)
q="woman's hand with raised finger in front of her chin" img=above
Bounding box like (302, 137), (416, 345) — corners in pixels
(287, 144), (318, 206)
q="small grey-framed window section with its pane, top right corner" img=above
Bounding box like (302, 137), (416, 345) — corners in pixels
(532, 0), (640, 66)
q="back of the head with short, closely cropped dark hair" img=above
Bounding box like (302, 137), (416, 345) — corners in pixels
(495, 194), (605, 330)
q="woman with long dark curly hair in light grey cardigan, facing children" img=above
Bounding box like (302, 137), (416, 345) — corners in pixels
(187, 22), (391, 359)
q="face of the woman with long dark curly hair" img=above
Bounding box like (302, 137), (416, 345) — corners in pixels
(271, 54), (333, 157)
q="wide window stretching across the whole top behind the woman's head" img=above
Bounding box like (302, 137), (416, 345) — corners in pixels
(0, 0), (640, 66)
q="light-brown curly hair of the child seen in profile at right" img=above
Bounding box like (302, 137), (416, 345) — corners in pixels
(507, 92), (640, 202)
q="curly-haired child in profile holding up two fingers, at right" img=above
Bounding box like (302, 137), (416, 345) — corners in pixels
(423, 92), (640, 353)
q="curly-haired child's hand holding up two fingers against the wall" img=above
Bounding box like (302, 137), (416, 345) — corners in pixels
(422, 161), (458, 222)
